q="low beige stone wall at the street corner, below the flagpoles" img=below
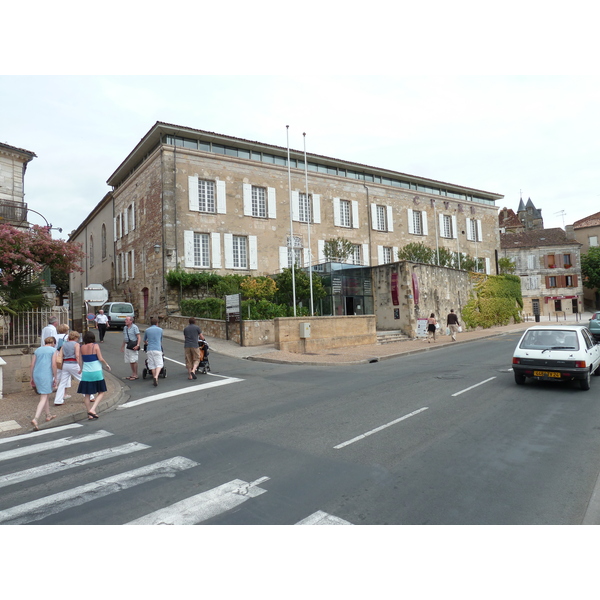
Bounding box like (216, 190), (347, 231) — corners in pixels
(275, 315), (377, 354)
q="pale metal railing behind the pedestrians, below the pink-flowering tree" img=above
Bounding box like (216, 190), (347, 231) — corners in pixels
(0, 306), (69, 348)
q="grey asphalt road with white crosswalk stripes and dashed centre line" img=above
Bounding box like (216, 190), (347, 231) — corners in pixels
(0, 332), (600, 525)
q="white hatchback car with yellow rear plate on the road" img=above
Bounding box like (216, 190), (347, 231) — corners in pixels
(513, 325), (600, 390)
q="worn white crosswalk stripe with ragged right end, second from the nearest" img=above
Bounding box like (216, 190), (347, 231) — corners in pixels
(127, 477), (269, 525)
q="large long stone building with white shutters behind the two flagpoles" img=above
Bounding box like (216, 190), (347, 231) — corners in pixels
(69, 122), (502, 318)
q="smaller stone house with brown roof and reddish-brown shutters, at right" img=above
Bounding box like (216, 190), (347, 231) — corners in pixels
(500, 227), (583, 317)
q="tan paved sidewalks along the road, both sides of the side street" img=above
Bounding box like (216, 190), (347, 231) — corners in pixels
(0, 313), (591, 438)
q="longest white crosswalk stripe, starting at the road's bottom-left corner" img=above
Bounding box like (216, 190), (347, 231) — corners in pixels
(0, 456), (198, 525)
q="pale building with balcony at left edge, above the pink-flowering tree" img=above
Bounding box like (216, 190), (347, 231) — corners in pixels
(0, 143), (36, 227)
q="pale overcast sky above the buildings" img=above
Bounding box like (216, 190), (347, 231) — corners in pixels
(0, 74), (600, 237)
